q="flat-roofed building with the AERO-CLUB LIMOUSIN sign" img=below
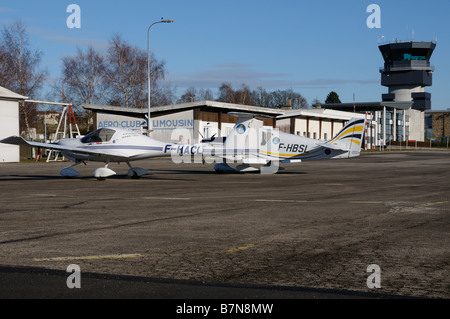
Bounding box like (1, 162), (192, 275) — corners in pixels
(83, 101), (283, 143)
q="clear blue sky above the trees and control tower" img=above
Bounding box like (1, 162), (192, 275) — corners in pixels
(0, 0), (450, 109)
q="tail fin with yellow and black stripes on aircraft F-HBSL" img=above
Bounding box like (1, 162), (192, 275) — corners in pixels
(324, 118), (366, 157)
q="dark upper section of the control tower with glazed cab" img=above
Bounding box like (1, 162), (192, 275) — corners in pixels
(378, 42), (436, 111)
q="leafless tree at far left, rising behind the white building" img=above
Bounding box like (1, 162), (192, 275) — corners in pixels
(0, 21), (47, 136)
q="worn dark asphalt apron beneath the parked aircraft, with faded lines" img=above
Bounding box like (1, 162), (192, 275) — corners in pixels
(0, 152), (450, 299)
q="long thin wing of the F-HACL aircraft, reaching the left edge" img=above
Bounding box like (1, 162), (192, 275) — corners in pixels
(0, 136), (129, 157)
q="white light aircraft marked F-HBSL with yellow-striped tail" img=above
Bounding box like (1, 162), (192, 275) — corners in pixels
(204, 113), (366, 173)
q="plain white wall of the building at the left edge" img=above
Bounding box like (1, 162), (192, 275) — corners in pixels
(0, 101), (20, 163)
